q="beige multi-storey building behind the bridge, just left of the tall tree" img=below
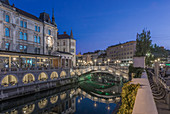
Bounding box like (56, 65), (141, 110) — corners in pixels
(106, 41), (136, 65)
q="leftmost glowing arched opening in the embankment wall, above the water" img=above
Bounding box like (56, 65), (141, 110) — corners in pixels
(1, 75), (18, 87)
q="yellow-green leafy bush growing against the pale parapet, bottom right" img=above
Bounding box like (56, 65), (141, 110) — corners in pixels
(118, 82), (140, 114)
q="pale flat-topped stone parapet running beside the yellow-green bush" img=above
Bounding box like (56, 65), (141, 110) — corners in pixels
(132, 72), (158, 114)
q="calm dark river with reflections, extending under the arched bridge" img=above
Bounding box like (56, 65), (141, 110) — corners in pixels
(0, 73), (125, 114)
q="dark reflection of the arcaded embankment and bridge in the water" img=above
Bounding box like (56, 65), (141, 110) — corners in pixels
(0, 85), (120, 114)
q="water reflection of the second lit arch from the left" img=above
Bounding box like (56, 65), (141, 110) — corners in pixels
(22, 104), (35, 114)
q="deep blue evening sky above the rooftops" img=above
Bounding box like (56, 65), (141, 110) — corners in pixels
(9, 0), (170, 53)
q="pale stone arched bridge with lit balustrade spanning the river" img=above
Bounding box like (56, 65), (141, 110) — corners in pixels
(71, 66), (129, 79)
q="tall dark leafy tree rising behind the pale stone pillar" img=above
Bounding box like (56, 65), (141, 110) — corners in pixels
(135, 29), (152, 56)
